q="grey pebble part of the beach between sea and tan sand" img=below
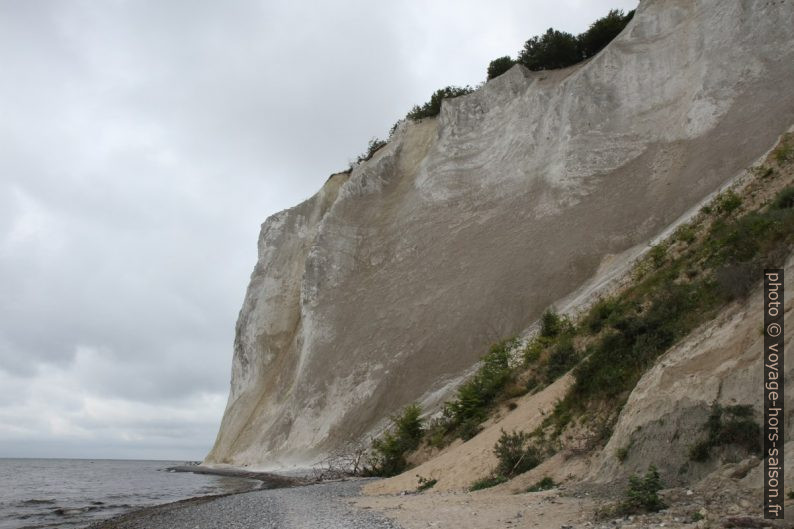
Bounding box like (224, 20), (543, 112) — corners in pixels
(89, 480), (400, 529)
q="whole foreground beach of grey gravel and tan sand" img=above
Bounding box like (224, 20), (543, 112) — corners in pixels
(86, 470), (780, 529)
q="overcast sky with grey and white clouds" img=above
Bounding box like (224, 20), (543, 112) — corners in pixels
(0, 0), (636, 459)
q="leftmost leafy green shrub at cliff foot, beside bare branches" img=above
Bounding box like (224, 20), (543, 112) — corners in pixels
(366, 404), (424, 476)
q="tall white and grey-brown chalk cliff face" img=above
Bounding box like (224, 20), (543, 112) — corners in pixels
(206, 0), (794, 467)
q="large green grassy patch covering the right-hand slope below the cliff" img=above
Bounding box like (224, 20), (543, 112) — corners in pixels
(547, 146), (794, 444)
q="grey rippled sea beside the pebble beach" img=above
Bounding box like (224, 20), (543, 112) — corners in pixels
(0, 458), (261, 529)
